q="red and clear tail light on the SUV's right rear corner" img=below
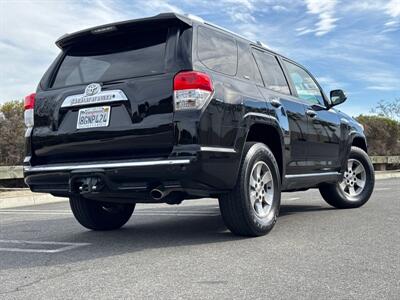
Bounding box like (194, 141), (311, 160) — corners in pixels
(174, 71), (214, 111)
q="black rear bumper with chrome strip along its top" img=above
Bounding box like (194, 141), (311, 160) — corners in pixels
(24, 147), (240, 198)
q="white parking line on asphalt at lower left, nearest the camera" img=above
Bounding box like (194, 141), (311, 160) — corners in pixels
(0, 240), (90, 253)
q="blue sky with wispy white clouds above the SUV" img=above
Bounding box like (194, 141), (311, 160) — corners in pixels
(0, 0), (400, 115)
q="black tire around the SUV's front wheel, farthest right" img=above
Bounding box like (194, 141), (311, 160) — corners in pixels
(319, 147), (375, 208)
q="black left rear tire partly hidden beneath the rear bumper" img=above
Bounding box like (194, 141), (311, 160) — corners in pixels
(69, 196), (135, 230)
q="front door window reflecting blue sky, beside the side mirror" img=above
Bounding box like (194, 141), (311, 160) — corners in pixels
(285, 61), (324, 105)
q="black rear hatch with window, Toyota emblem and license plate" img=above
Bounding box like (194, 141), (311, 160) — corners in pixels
(31, 16), (191, 165)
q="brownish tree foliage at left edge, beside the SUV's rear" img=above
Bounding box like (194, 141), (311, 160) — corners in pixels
(0, 101), (25, 165)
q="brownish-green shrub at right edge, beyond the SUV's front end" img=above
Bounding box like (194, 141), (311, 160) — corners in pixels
(357, 115), (400, 155)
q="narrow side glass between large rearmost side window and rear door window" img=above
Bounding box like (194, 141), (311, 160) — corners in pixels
(237, 41), (263, 85)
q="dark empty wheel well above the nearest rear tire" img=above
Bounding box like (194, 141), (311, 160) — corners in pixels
(246, 124), (283, 179)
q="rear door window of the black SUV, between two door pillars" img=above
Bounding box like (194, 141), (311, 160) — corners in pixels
(253, 49), (290, 95)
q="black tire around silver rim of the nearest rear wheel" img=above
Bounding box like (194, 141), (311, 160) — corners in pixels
(219, 143), (281, 236)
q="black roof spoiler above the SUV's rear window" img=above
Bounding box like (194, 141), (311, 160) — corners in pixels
(56, 13), (198, 50)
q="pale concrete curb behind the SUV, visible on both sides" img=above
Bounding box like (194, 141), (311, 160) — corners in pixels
(0, 170), (400, 209)
